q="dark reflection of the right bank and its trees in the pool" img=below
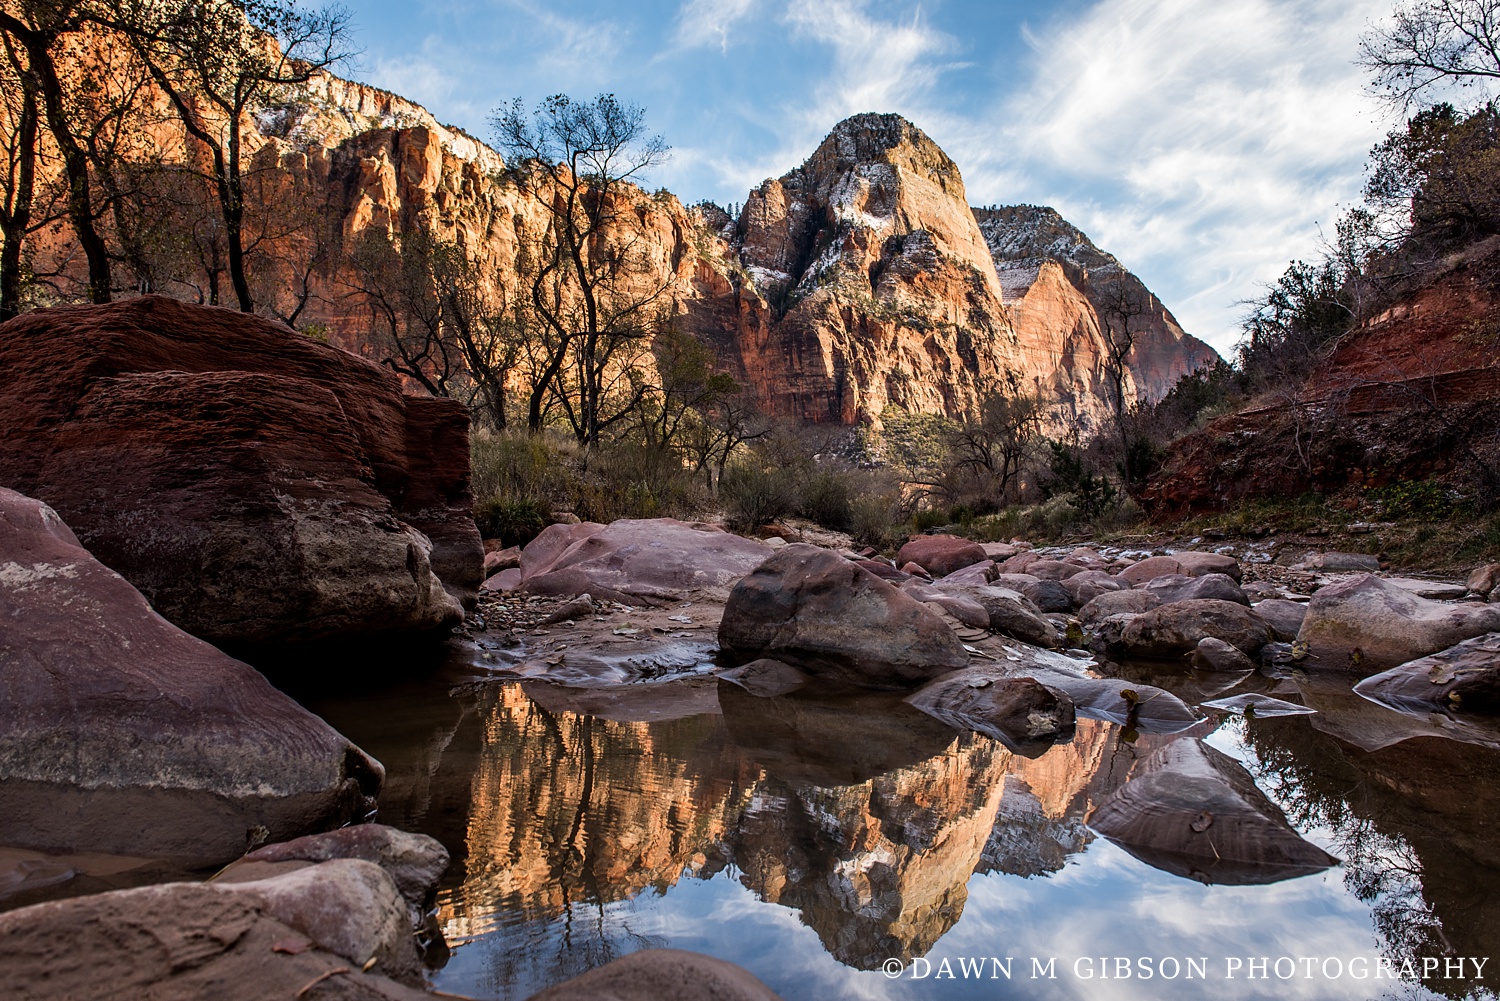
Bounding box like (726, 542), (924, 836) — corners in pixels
(1238, 717), (1500, 998)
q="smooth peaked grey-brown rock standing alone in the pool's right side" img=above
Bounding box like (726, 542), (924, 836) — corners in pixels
(1089, 740), (1338, 885)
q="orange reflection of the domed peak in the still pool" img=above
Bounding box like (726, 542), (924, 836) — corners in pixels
(726, 729), (1016, 969)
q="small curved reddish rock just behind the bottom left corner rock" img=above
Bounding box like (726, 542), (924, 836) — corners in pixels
(218, 824), (449, 912)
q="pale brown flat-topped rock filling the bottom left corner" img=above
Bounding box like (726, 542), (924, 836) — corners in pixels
(0, 858), (431, 1001)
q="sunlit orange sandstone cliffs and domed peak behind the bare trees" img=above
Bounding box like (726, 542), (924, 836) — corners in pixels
(20, 63), (1211, 435)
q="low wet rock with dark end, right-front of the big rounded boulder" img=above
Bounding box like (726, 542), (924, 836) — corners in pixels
(906, 671), (1074, 750)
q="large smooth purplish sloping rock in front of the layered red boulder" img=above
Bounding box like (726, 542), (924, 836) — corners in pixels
(0, 488), (383, 864)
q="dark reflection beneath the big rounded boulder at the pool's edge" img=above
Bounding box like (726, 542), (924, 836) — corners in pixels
(719, 681), (959, 786)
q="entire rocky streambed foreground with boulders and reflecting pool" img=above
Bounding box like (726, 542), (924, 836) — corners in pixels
(0, 299), (1500, 999)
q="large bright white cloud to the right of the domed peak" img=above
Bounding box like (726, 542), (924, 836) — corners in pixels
(959, 0), (1389, 348)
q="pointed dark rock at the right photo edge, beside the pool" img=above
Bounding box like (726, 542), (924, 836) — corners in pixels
(1355, 632), (1500, 713)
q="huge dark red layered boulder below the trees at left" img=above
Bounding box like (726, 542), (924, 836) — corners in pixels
(0, 296), (483, 642)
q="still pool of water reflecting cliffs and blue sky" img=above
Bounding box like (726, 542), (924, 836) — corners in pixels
(312, 657), (1500, 1001)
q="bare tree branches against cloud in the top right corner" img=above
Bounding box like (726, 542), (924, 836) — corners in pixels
(1359, 0), (1500, 111)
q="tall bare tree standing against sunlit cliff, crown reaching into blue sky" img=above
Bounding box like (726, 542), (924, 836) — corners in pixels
(492, 95), (672, 446)
